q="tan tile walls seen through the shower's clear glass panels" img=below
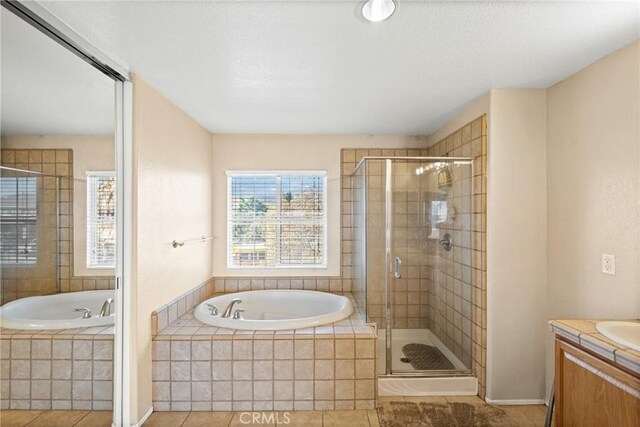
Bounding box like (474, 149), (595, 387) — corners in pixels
(352, 153), (472, 358)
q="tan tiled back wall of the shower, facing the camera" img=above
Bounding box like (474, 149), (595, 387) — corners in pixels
(342, 149), (427, 329)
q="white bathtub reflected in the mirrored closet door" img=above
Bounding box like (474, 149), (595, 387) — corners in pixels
(0, 290), (115, 329)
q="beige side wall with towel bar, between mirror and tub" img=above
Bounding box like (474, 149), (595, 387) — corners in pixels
(131, 76), (214, 420)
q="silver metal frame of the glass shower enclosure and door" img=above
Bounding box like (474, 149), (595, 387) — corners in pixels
(350, 156), (474, 378)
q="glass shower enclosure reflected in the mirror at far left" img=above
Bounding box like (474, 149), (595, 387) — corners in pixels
(0, 166), (60, 304)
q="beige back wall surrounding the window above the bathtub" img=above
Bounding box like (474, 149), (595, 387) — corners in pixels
(213, 135), (426, 277)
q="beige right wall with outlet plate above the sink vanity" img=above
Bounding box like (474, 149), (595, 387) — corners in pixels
(547, 42), (640, 396)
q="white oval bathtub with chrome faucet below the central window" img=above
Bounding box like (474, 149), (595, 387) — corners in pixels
(194, 289), (353, 330)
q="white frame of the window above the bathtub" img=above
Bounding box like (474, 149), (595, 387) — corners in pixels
(225, 170), (329, 271)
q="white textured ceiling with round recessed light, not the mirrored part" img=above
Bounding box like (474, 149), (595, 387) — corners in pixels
(5, 0), (640, 134)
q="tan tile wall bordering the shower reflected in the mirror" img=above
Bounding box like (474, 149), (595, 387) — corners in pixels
(0, 149), (115, 304)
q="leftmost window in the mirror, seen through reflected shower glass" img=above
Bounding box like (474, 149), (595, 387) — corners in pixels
(0, 176), (38, 266)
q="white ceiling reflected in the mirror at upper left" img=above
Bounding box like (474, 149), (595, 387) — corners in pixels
(0, 8), (114, 135)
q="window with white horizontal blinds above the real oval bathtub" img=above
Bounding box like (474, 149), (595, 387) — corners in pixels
(227, 172), (327, 268)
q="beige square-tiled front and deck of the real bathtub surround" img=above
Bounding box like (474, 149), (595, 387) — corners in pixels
(153, 294), (376, 411)
